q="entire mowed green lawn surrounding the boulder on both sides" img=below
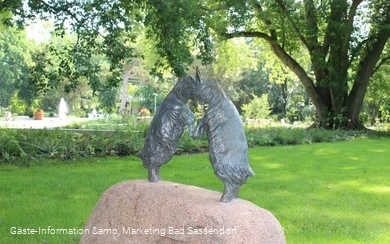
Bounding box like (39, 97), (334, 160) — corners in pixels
(0, 138), (390, 244)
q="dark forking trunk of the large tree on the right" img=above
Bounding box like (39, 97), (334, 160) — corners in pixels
(266, 4), (390, 129)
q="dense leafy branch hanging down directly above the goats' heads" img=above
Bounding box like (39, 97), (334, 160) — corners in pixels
(143, 0), (212, 77)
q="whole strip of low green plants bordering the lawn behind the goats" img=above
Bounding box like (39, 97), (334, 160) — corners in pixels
(0, 119), (390, 165)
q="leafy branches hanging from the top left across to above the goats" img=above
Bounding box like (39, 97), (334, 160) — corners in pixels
(10, 0), (212, 91)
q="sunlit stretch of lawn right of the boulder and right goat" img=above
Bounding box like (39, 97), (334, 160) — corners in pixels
(241, 139), (390, 243)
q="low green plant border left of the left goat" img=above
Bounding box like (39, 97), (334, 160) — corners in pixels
(0, 129), (139, 164)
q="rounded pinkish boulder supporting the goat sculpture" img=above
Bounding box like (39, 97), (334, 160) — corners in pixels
(81, 180), (286, 244)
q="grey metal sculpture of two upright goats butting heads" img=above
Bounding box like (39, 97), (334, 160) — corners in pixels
(137, 69), (254, 203)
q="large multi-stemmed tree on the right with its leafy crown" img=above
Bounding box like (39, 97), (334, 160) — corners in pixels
(194, 0), (390, 129)
